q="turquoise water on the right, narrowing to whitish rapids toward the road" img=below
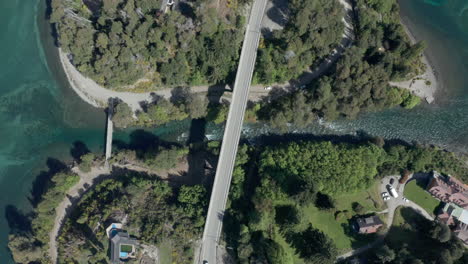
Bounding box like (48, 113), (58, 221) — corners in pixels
(245, 0), (468, 152)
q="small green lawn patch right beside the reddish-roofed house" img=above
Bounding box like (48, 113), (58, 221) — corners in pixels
(405, 180), (440, 215)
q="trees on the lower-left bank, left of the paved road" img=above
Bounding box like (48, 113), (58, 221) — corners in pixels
(8, 142), (201, 263)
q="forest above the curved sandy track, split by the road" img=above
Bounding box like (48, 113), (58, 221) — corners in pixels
(51, 0), (343, 88)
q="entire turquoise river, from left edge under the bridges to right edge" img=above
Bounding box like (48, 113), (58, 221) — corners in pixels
(0, 0), (468, 264)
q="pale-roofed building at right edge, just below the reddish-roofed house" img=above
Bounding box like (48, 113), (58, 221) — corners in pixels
(437, 203), (468, 244)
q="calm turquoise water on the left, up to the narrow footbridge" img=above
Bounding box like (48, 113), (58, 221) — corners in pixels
(0, 0), (190, 263)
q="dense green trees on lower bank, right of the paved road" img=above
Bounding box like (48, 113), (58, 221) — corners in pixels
(225, 138), (468, 264)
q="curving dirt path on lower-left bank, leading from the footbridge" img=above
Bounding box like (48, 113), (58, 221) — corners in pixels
(49, 167), (110, 264)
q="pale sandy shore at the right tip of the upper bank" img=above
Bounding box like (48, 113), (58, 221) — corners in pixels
(390, 18), (439, 103)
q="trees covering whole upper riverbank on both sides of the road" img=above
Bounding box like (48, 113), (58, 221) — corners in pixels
(51, 0), (436, 127)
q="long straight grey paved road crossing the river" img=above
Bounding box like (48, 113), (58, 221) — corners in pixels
(199, 0), (267, 264)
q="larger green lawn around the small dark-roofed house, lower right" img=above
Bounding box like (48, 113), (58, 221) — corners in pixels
(304, 181), (383, 252)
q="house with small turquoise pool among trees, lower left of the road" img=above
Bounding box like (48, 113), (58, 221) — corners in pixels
(106, 224), (137, 264)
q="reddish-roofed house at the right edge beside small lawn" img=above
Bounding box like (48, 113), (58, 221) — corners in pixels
(426, 171), (468, 209)
